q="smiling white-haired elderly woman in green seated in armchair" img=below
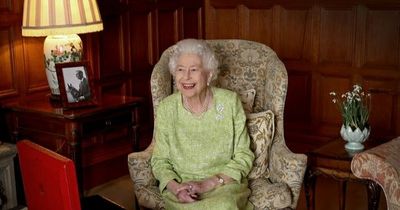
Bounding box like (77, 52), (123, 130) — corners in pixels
(151, 39), (254, 210)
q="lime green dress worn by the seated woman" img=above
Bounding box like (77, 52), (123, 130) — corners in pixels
(151, 88), (254, 210)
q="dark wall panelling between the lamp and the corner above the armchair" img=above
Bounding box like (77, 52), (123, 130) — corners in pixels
(91, 0), (204, 136)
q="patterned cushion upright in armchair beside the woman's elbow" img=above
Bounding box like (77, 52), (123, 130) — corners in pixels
(247, 110), (275, 179)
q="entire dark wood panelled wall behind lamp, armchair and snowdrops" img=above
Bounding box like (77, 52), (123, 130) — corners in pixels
(0, 0), (400, 150)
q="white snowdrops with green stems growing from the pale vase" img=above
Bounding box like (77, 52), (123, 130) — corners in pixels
(329, 85), (371, 131)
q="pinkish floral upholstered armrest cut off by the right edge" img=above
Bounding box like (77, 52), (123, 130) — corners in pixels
(351, 137), (400, 210)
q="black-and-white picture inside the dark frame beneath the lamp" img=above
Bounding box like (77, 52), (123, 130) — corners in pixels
(63, 66), (91, 103)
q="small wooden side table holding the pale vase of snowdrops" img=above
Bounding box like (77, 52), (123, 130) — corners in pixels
(304, 138), (381, 210)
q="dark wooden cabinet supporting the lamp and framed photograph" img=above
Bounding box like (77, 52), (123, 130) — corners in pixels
(4, 95), (142, 190)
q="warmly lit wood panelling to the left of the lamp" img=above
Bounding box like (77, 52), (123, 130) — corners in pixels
(0, 0), (48, 99)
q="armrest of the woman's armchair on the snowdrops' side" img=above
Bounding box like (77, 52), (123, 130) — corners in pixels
(269, 141), (307, 209)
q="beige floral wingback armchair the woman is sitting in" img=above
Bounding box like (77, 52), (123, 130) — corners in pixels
(128, 40), (307, 209)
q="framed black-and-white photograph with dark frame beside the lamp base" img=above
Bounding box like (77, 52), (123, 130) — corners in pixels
(56, 61), (96, 108)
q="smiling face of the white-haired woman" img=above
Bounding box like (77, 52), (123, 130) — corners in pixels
(175, 54), (210, 98)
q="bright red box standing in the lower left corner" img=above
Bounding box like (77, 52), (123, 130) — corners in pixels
(17, 140), (124, 210)
